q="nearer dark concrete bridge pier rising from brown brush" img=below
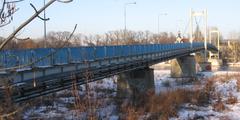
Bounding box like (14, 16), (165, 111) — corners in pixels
(117, 68), (155, 105)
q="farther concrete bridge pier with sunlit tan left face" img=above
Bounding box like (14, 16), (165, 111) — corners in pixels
(171, 55), (196, 78)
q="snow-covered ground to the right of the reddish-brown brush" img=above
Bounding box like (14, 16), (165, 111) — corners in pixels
(168, 71), (240, 120)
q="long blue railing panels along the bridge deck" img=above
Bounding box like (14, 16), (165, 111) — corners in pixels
(0, 43), (215, 68)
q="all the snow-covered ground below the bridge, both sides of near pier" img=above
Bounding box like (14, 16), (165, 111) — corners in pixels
(23, 70), (240, 120)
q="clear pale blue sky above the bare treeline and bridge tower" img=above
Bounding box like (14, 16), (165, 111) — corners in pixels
(0, 0), (240, 38)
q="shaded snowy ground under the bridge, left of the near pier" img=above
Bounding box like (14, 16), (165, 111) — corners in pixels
(23, 77), (118, 120)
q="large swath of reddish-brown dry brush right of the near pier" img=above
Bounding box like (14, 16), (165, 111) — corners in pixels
(118, 80), (214, 120)
